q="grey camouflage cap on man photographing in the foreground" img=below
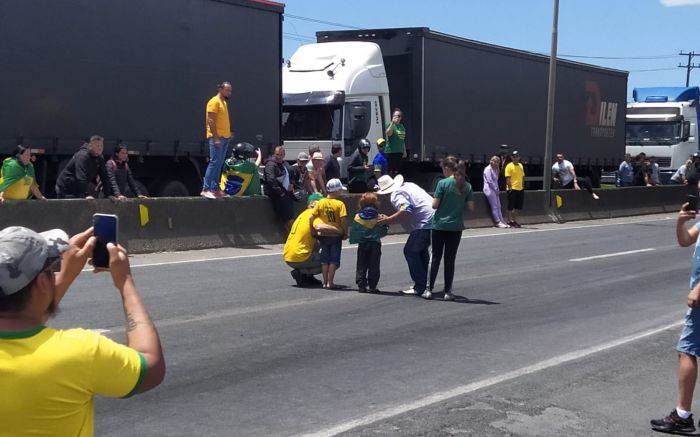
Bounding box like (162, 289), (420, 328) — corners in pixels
(0, 226), (69, 296)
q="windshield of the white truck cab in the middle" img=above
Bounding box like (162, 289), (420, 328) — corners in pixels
(282, 105), (341, 141)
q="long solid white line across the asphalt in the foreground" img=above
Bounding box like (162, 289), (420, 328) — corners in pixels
(302, 320), (683, 437)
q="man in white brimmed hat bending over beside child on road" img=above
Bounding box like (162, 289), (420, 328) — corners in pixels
(377, 174), (435, 295)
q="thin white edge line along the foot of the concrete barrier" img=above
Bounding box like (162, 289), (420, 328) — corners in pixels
(116, 217), (672, 271)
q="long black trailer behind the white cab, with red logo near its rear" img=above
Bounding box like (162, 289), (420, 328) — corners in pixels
(316, 28), (628, 188)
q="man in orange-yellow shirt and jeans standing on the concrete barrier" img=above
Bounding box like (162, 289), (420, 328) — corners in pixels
(200, 82), (233, 199)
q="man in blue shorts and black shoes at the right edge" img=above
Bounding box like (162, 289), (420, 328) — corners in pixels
(651, 203), (700, 433)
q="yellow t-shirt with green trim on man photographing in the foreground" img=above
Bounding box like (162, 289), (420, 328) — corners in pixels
(0, 326), (146, 437)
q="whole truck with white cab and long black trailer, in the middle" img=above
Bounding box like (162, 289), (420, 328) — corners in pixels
(282, 27), (628, 189)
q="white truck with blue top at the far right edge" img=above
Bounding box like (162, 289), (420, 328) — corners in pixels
(625, 86), (700, 183)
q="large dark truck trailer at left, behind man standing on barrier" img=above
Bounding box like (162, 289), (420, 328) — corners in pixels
(0, 0), (284, 196)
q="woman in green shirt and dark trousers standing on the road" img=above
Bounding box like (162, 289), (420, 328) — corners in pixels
(423, 156), (474, 300)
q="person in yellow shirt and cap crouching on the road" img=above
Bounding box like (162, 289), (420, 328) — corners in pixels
(282, 193), (338, 287)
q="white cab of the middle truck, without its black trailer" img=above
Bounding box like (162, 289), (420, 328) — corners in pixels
(282, 42), (391, 177)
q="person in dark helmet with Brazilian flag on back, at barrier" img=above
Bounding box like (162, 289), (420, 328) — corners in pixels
(221, 143), (262, 197)
